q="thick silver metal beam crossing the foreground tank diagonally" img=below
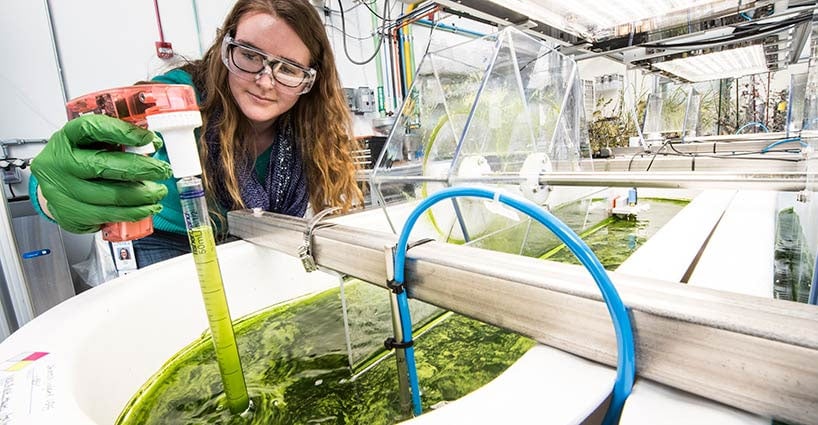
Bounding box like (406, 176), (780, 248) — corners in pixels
(228, 210), (818, 423)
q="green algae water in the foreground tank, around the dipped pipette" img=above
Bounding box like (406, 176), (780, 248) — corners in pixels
(118, 282), (534, 424)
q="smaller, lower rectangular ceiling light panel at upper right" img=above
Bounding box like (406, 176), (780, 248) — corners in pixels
(653, 44), (767, 82)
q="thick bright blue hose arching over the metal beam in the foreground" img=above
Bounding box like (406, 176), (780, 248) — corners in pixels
(395, 187), (636, 425)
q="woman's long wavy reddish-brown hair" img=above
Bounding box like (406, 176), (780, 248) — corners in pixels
(183, 0), (363, 217)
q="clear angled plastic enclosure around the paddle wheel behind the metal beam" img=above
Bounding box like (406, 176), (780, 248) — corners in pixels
(371, 28), (590, 241)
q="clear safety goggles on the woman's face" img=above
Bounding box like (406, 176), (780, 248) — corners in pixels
(222, 35), (317, 95)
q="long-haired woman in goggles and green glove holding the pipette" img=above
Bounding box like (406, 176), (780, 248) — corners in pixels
(30, 0), (362, 267)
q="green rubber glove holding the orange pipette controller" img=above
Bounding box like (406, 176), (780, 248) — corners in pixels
(31, 115), (171, 233)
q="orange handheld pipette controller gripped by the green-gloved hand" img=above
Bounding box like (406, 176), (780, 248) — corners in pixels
(65, 84), (199, 242)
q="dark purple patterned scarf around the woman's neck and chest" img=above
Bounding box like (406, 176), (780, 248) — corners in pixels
(205, 111), (309, 217)
